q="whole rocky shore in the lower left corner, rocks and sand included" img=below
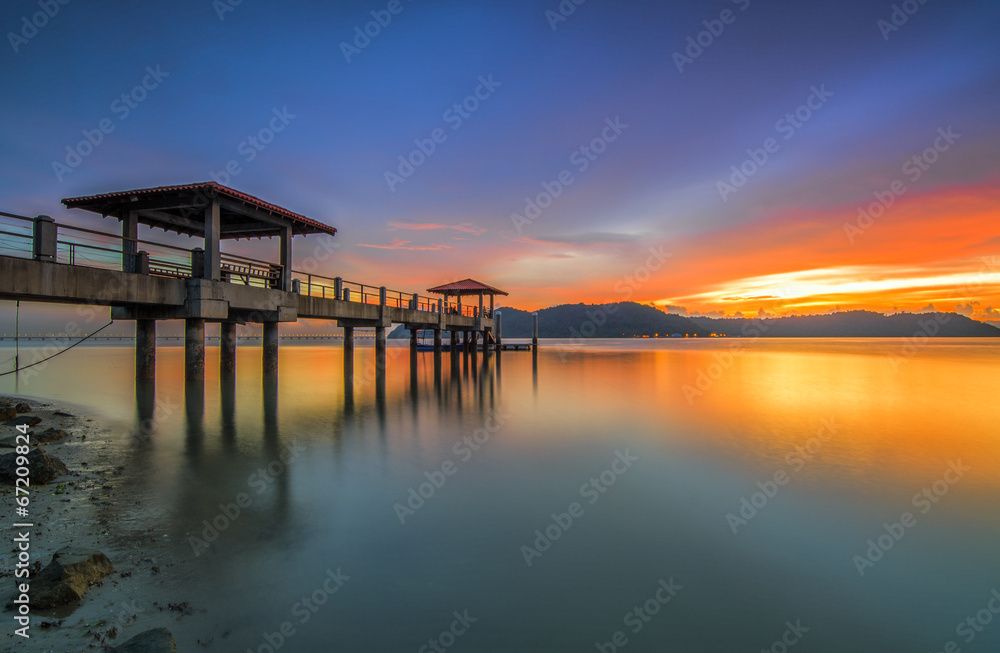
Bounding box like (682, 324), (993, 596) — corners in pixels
(0, 396), (189, 653)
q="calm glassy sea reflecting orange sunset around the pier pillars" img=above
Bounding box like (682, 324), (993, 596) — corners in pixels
(0, 339), (1000, 653)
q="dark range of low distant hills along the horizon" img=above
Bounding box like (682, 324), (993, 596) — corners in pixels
(389, 302), (1000, 338)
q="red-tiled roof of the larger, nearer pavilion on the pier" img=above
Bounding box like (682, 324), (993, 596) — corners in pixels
(62, 181), (337, 237)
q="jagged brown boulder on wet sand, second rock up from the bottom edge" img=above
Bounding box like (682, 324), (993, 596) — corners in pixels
(7, 546), (115, 610)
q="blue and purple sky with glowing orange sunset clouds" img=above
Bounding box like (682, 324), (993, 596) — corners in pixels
(0, 0), (1000, 320)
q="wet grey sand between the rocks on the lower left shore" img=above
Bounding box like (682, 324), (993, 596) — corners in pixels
(0, 396), (207, 653)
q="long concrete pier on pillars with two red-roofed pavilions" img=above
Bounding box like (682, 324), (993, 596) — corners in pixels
(0, 182), (537, 381)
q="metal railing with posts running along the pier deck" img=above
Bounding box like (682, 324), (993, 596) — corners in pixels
(0, 211), (492, 317)
